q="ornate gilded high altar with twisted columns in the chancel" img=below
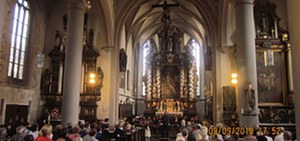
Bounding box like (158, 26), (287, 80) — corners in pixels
(143, 3), (198, 115)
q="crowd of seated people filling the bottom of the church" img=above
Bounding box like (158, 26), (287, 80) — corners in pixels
(0, 115), (293, 141)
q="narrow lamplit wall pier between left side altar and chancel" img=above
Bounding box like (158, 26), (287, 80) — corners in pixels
(88, 6), (113, 119)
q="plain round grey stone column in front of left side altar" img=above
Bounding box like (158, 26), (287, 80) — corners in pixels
(62, 0), (87, 125)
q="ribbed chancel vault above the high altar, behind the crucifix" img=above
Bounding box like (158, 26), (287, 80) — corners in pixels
(115, 0), (218, 50)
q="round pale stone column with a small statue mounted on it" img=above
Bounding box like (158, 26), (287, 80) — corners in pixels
(235, 0), (259, 127)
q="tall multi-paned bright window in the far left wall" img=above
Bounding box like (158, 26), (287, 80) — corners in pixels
(7, 0), (30, 80)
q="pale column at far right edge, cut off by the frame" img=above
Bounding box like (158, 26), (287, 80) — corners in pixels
(287, 0), (300, 137)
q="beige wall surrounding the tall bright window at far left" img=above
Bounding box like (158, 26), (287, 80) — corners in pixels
(0, 0), (45, 123)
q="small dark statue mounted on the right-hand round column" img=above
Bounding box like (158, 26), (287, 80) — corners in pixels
(245, 81), (256, 113)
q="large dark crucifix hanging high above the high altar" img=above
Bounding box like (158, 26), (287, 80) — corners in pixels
(152, 0), (179, 52)
